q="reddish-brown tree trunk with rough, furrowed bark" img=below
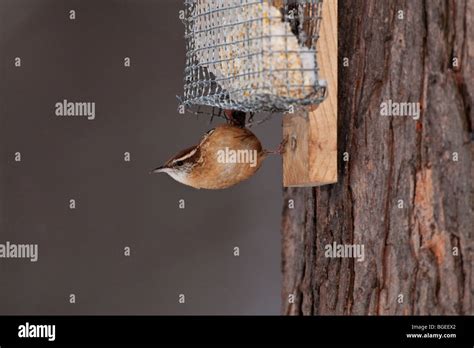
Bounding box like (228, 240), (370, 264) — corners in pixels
(282, 0), (474, 315)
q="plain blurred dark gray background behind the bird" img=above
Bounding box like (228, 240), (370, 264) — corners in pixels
(0, 0), (282, 314)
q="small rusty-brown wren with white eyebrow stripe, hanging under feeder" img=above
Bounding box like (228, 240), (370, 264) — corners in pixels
(151, 124), (281, 189)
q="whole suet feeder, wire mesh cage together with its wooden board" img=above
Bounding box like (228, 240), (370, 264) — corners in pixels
(182, 0), (337, 186)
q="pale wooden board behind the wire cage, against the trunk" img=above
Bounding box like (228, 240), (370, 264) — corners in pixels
(283, 0), (338, 187)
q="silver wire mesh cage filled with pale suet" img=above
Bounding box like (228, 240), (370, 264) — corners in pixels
(182, 0), (326, 112)
